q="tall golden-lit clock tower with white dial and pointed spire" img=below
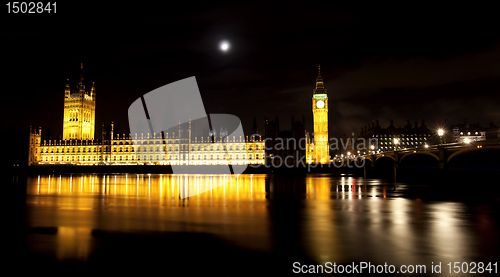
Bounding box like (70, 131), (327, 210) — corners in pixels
(309, 66), (330, 164)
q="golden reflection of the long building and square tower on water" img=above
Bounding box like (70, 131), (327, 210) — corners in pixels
(27, 174), (270, 260)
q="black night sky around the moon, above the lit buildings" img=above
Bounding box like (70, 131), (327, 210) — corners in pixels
(0, 1), (500, 138)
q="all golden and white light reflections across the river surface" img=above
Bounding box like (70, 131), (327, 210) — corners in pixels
(26, 174), (499, 270)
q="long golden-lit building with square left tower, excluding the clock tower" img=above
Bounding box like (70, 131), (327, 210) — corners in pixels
(28, 66), (265, 165)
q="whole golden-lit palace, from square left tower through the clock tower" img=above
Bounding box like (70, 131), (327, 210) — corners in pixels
(28, 65), (330, 165)
